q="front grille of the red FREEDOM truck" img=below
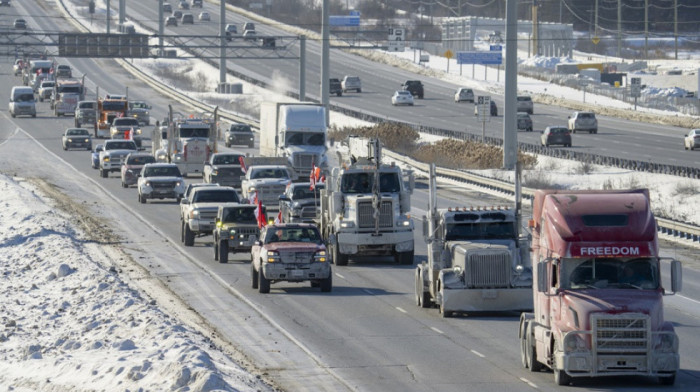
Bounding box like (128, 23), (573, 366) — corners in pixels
(591, 314), (651, 354)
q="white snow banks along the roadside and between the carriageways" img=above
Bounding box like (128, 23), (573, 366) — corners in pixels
(0, 1), (700, 392)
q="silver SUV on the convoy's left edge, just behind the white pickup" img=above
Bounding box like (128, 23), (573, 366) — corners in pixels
(136, 163), (185, 204)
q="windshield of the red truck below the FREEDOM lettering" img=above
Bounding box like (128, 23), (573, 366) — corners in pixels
(560, 258), (659, 290)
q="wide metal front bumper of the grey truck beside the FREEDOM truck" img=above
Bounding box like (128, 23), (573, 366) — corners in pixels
(440, 288), (533, 312)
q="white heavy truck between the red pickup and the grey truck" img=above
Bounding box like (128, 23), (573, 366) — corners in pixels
(319, 137), (414, 265)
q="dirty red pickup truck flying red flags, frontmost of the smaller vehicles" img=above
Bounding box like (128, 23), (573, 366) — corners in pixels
(250, 223), (333, 294)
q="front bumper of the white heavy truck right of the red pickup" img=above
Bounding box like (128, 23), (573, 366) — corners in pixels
(337, 231), (413, 256)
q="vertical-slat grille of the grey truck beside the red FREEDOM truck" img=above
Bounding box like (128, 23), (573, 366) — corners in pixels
(465, 250), (511, 289)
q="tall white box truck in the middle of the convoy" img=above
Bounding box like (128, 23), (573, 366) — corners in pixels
(260, 102), (328, 180)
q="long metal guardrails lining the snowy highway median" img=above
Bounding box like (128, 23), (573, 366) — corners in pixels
(57, 0), (700, 243)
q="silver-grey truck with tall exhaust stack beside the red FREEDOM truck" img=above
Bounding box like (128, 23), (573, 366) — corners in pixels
(415, 164), (532, 317)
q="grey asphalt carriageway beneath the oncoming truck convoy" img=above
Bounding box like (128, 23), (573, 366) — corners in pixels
(0, 1), (700, 391)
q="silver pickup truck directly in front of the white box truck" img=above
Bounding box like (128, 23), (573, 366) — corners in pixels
(241, 157), (292, 211)
